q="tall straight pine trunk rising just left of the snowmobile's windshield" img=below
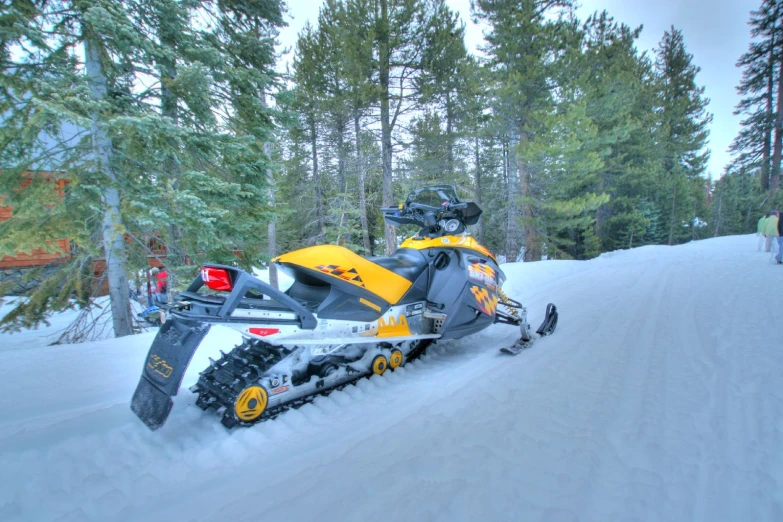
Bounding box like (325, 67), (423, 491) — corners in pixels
(378, 0), (397, 255)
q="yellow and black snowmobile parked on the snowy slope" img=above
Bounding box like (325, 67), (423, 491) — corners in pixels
(131, 185), (557, 430)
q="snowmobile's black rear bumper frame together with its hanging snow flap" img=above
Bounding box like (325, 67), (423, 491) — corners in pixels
(131, 265), (318, 430)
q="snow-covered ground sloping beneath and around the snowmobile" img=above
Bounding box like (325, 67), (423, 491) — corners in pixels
(0, 236), (783, 522)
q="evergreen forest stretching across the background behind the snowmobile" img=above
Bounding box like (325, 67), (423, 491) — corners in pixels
(0, 0), (783, 336)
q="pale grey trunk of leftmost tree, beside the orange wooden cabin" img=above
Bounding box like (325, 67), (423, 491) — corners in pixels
(84, 31), (133, 337)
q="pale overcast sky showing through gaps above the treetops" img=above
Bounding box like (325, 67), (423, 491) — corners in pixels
(279, 0), (761, 178)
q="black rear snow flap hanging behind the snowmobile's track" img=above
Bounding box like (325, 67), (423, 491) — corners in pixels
(131, 316), (211, 430)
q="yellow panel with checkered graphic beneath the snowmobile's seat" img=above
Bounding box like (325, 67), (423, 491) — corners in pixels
(272, 245), (412, 304)
